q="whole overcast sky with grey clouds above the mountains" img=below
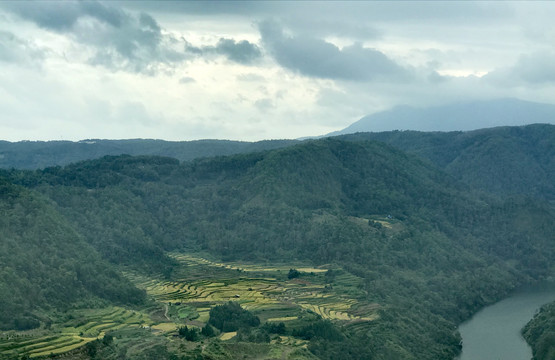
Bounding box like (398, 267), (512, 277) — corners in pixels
(0, 0), (555, 141)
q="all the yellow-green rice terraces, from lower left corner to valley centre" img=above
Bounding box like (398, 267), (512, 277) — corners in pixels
(0, 253), (379, 359)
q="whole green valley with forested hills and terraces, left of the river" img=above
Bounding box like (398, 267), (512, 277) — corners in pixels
(0, 134), (555, 360)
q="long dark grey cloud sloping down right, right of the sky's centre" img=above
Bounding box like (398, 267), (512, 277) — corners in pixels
(259, 21), (410, 81)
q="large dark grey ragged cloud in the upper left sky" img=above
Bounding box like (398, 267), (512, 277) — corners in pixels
(4, 1), (187, 74)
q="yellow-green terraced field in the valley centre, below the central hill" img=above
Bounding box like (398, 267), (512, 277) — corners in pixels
(127, 254), (377, 322)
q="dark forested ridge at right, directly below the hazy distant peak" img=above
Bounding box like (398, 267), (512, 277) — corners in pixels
(339, 124), (555, 200)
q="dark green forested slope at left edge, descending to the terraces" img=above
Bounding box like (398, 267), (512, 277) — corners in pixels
(0, 178), (145, 330)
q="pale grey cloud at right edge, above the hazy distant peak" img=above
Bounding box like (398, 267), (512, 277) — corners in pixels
(483, 52), (555, 86)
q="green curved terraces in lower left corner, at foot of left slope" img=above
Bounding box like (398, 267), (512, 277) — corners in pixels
(0, 307), (152, 359)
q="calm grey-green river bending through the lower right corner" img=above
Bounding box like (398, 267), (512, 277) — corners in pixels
(457, 282), (555, 360)
